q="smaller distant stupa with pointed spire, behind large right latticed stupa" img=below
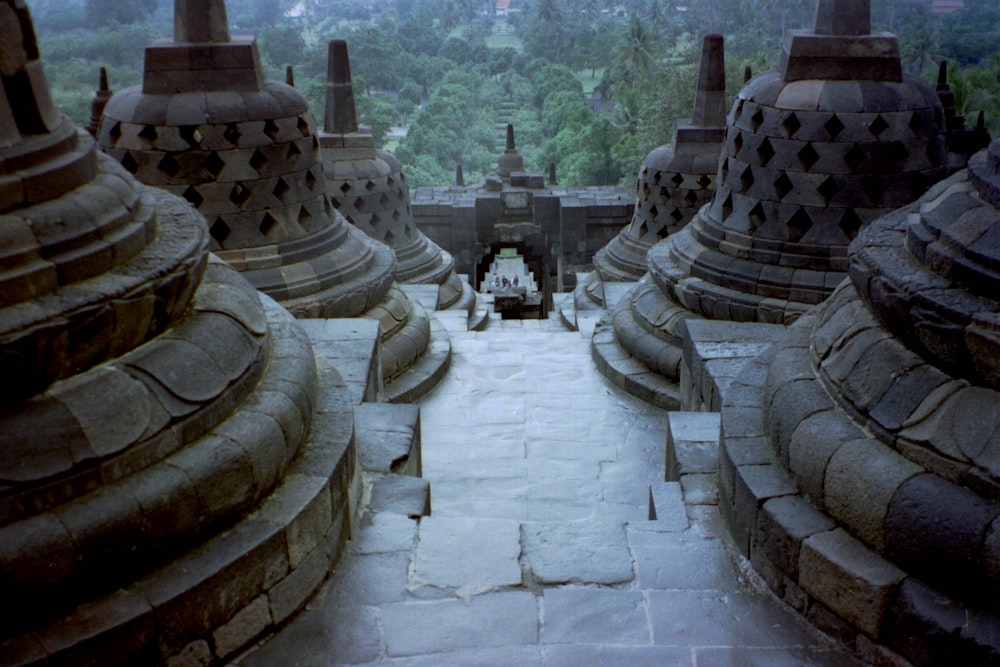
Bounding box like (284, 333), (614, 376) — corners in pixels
(574, 34), (726, 310)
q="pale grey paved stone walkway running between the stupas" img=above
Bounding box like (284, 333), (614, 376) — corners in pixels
(235, 320), (858, 667)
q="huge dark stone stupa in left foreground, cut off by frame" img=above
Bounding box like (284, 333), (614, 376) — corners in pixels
(0, 0), (360, 665)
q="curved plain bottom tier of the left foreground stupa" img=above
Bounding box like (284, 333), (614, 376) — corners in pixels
(0, 309), (362, 667)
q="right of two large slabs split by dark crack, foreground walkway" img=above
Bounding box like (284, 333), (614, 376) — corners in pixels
(521, 520), (635, 585)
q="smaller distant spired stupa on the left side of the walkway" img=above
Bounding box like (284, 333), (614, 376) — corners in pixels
(319, 40), (475, 312)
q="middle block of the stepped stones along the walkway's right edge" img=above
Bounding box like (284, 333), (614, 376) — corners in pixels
(664, 412), (720, 505)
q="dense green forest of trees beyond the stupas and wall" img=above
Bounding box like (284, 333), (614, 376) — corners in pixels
(30, 0), (1000, 186)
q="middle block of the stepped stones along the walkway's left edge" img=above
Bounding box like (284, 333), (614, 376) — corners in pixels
(354, 403), (422, 477)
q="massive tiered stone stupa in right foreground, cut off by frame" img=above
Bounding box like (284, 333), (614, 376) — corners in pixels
(719, 141), (1000, 665)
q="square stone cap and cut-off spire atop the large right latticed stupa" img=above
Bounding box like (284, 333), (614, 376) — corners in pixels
(781, 0), (903, 82)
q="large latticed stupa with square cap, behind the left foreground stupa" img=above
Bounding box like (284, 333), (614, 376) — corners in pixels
(99, 0), (440, 397)
